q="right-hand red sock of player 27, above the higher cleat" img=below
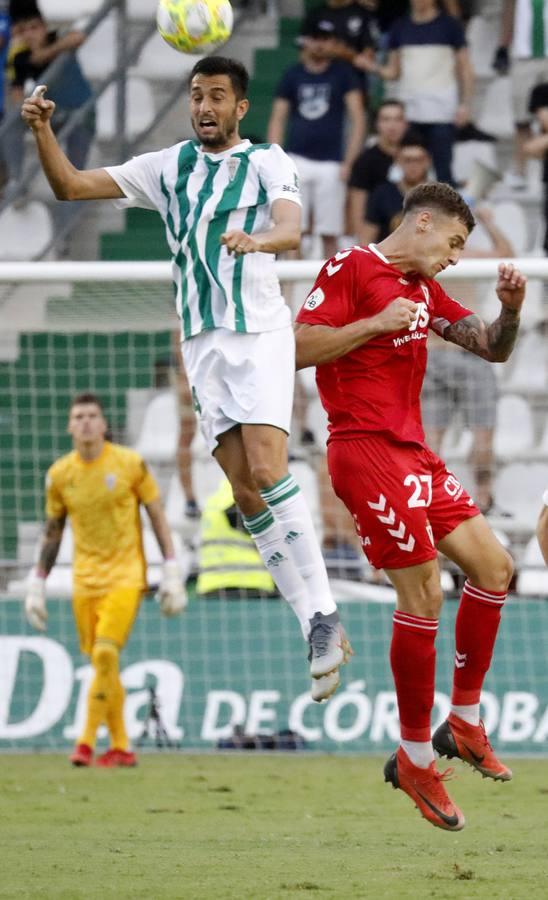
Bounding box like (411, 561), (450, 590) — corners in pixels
(451, 581), (506, 706)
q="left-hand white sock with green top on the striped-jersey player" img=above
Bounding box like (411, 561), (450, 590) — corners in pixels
(243, 509), (310, 641)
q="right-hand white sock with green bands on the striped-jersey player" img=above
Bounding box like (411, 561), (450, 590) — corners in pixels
(261, 475), (337, 619)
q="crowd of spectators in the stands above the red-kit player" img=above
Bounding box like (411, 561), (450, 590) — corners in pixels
(262, 0), (548, 256)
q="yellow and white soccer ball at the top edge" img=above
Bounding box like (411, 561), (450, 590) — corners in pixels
(156, 0), (234, 53)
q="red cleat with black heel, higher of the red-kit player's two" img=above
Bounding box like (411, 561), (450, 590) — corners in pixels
(432, 713), (512, 781)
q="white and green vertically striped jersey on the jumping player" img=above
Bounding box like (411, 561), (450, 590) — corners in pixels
(106, 140), (301, 339)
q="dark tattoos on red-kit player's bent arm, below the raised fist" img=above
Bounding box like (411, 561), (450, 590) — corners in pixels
(444, 306), (519, 362)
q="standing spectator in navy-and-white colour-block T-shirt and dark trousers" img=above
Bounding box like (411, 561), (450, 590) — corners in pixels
(367, 0), (474, 184)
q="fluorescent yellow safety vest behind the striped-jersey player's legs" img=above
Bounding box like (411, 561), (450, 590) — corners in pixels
(196, 479), (275, 594)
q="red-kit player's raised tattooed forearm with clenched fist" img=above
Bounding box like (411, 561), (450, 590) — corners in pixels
(444, 263), (527, 362)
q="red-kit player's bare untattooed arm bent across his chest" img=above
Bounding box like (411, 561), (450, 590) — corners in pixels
(295, 297), (418, 369)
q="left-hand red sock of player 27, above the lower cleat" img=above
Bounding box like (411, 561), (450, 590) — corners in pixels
(390, 610), (438, 741)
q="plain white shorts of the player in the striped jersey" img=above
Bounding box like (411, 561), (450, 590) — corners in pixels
(182, 325), (295, 452)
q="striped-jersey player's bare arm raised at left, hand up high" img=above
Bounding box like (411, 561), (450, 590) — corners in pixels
(21, 84), (124, 200)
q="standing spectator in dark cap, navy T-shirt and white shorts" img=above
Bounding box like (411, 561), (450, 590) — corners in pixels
(268, 22), (365, 258)
